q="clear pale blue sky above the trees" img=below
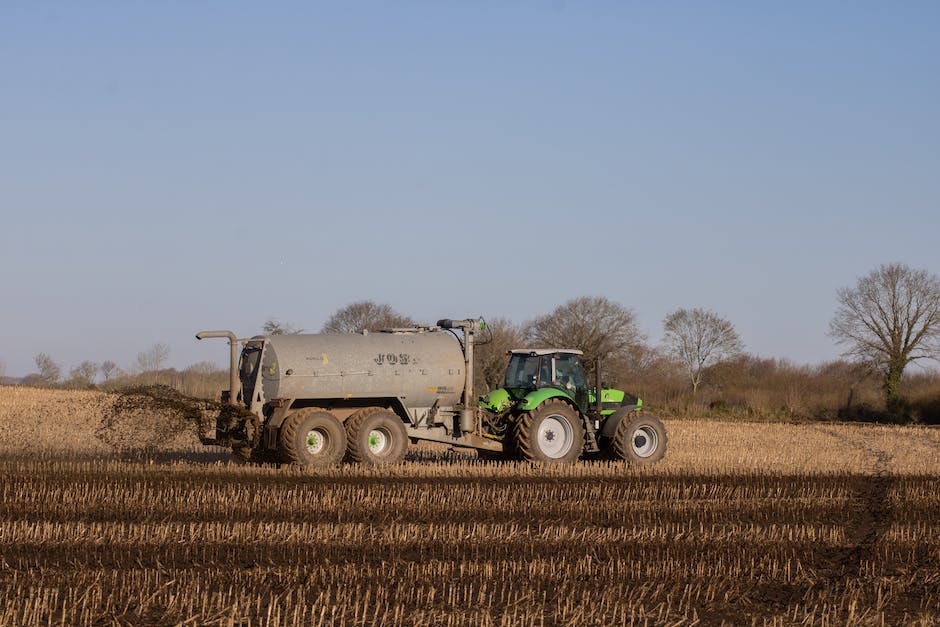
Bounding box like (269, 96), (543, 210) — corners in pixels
(0, 1), (940, 376)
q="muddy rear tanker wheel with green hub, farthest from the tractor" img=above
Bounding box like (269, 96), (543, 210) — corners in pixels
(278, 409), (346, 466)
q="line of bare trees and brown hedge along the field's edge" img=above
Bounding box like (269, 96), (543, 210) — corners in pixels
(12, 263), (940, 422)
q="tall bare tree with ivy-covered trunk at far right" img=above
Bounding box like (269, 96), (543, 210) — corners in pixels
(829, 263), (940, 413)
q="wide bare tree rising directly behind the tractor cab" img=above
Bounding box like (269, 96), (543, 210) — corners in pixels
(525, 296), (645, 367)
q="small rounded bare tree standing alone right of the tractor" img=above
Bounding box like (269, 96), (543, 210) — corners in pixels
(663, 308), (743, 396)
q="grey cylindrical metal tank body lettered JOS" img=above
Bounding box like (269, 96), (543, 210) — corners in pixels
(253, 330), (465, 407)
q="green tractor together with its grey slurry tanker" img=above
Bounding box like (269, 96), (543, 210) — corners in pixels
(196, 319), (666, 466)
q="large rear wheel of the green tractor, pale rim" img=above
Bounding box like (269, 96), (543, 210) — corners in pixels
(514, 401), (584, 464)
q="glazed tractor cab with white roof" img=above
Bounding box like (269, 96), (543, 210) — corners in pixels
(503, 349), (588, 409)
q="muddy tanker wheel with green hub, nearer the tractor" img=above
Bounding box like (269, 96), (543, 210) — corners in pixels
(346, 407), (408, 466)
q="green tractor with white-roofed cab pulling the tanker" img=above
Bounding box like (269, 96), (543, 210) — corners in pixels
(480, 349), (666, 464)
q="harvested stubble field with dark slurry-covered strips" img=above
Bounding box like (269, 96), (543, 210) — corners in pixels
(0, 388), (940, 625)
